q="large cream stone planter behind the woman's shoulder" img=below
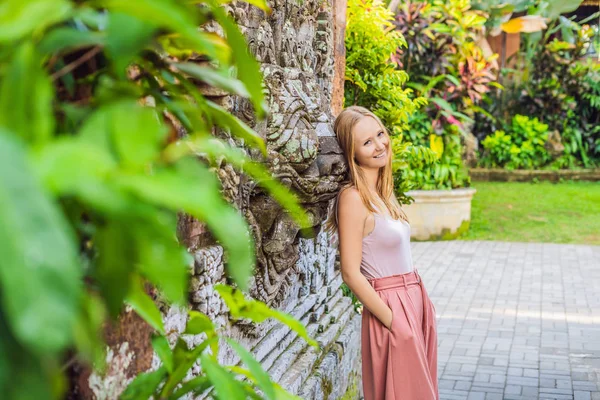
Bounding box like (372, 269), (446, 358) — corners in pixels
(403, 188), (476, 241)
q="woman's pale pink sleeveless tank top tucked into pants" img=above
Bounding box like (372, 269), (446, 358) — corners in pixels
(360, 214), (414, 279)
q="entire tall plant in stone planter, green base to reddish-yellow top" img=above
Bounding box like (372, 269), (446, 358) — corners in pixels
(394, 0), (496, 189)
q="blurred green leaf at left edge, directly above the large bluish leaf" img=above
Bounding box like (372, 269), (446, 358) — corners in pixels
(0, 40), (55, 145)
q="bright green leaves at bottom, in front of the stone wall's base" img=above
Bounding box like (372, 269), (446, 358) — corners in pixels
(122, 302), (311, 400)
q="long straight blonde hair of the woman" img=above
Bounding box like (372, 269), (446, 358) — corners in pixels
(326, 106), (408, 232)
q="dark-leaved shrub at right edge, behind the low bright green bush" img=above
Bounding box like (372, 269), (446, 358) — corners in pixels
(477, 11), (600, 168)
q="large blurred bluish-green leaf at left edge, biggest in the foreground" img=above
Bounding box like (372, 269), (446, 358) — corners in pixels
(0, 131), (82, 355)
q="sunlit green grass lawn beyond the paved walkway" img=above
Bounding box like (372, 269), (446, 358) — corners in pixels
(459, 181), (600, 245)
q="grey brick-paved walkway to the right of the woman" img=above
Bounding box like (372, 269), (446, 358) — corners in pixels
(413, 241), (600, 400)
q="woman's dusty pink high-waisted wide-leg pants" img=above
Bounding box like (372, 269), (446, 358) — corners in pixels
(361, 270), (439, 400)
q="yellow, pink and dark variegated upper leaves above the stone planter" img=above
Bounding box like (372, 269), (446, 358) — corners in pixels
(394, 0), (496, 120)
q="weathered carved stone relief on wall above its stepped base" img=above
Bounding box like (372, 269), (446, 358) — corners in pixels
(202, 0), (345, 306)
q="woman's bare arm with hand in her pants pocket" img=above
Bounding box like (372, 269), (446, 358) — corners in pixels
(337, 188), (393, 329)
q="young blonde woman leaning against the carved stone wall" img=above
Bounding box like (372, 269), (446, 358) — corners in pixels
(329, 106), (439, 400)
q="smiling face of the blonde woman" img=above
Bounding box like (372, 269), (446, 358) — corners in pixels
(352, 117), (390, 169)
